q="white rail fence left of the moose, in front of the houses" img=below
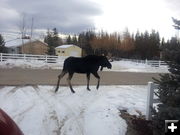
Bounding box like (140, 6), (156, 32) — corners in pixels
(0, 53), (59, 63)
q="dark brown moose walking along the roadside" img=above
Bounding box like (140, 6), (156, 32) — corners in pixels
(55, 55), (112, 93)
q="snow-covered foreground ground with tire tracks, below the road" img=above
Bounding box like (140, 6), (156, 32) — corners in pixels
(0, 85), (147, 135)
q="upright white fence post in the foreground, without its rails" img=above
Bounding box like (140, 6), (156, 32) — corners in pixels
(146, 82), (154, 120)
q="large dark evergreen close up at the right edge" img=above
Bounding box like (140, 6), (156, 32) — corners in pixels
(153, 18), (180, 135)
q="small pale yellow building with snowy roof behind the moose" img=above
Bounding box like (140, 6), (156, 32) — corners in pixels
(55, 44), (82, 57)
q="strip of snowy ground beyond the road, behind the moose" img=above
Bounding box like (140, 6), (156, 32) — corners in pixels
(0, 57), (168, 73)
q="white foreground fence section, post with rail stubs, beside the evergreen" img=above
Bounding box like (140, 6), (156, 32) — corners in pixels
(146, 82), (160, 120)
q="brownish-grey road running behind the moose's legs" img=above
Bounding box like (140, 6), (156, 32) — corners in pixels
(0, 68), (163, 85)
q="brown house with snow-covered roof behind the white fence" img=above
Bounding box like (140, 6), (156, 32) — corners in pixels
(7, 40), (48, 55)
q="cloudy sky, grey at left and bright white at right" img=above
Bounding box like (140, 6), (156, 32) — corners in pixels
(0, 0), (180, 40)
